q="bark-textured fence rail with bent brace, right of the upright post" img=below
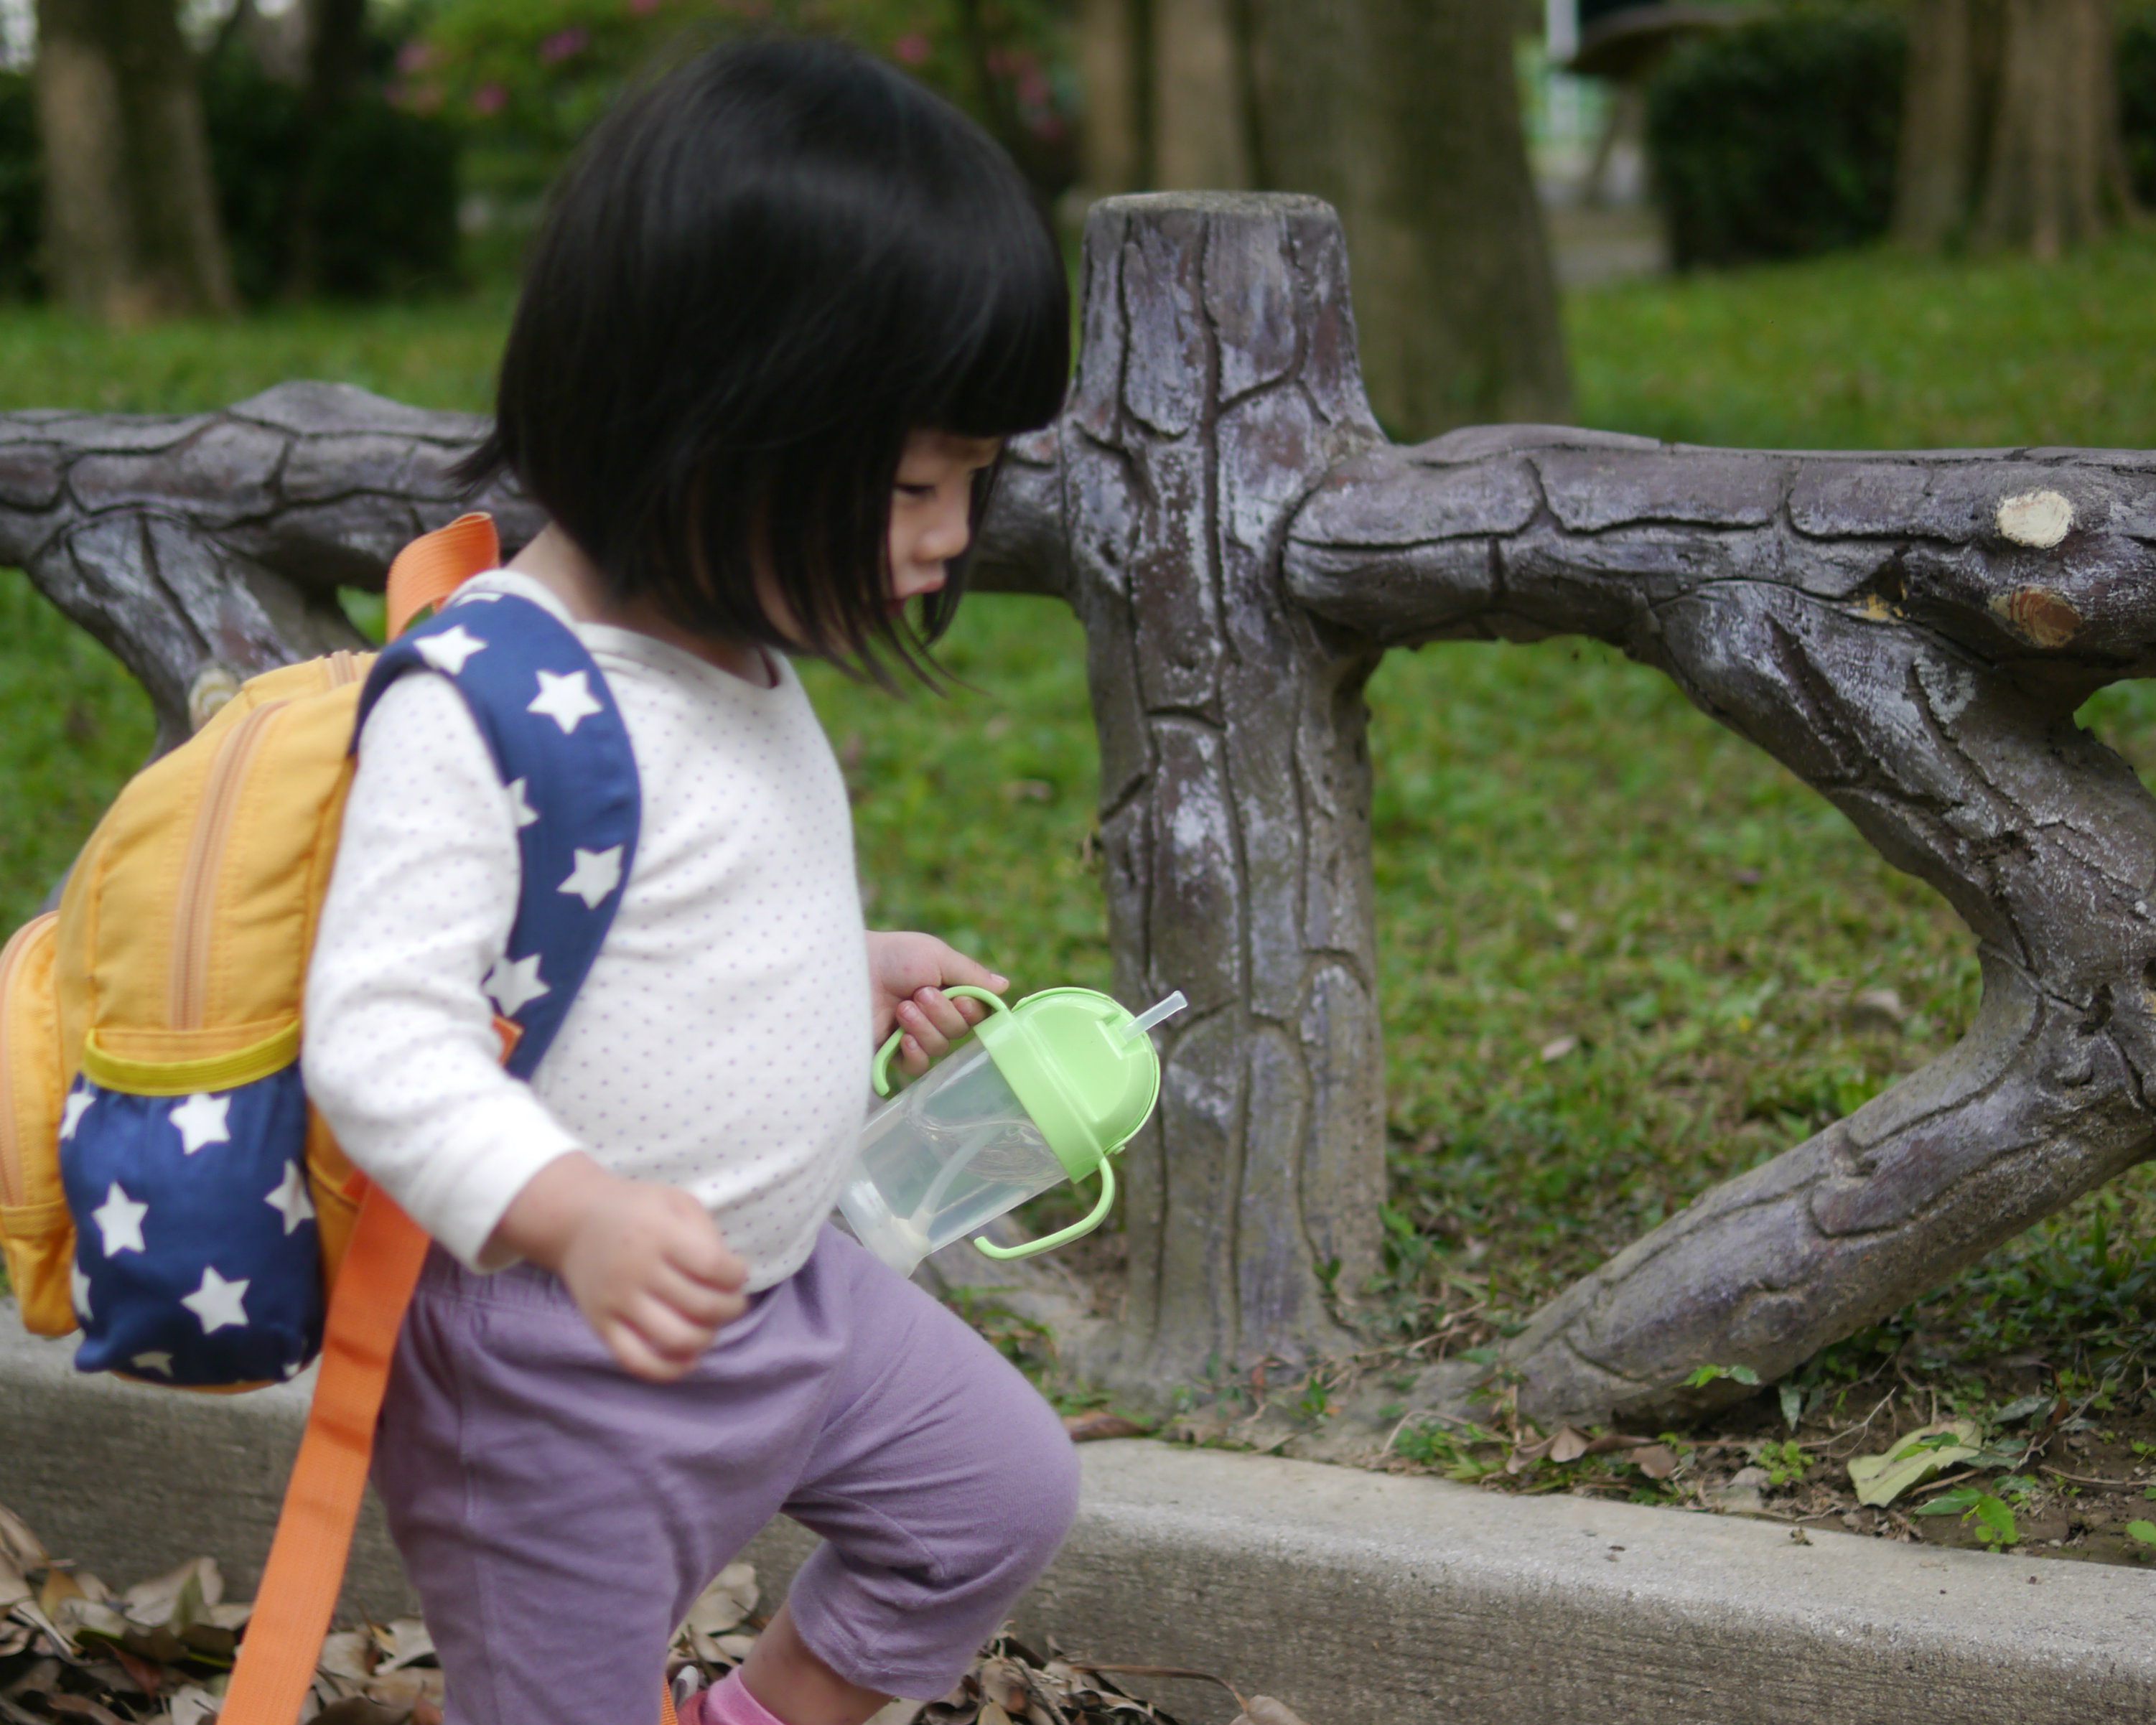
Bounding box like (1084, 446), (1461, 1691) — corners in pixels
(1287, 427), (2156, 1416)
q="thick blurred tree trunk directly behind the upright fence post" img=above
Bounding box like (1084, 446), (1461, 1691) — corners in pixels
(1251, 0), (1572, 438)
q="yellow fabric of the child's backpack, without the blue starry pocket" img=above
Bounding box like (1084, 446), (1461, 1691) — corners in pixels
(0, 653), (373, 1334)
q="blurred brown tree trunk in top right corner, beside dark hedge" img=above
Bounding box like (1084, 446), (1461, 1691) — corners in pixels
(1893, 0), (2132, 256)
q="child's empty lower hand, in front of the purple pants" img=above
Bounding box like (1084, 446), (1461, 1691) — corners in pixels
(487, 1156), (748, 1384)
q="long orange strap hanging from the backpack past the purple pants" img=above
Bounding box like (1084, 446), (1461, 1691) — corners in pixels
(218, 1186), (427, 1725)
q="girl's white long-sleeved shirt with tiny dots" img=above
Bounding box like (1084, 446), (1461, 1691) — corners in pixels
(304, 571), (871, 1289)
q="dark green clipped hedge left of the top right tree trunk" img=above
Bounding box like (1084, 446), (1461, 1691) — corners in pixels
(1647, 4), (1908, 269)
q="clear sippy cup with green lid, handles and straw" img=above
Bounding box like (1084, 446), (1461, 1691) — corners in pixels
(839, 983), (1188, 1276)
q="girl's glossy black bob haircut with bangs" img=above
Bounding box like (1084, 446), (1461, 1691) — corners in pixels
(459, 39), (1069, 681)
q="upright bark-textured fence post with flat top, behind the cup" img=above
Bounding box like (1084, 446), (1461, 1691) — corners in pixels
(1058, 196), (1384, 1390)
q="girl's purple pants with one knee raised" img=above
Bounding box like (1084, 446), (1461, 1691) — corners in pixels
(375, 1227), (1078, 1725)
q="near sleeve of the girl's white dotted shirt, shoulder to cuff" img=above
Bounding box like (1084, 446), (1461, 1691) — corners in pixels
(302, 675), (580, 1268)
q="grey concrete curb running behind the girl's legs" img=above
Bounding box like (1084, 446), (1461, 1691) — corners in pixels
(0, 1311), (2156, 1725)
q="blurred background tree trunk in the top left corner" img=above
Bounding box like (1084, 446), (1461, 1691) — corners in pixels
(37, 0), (233, 324)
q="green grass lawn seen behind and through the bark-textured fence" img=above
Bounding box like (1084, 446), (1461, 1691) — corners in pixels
(0, 235), (2156, 1380)
